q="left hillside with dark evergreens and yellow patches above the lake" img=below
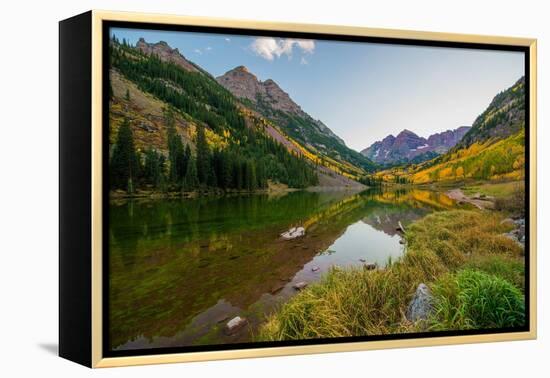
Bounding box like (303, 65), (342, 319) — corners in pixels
(109, 38), (364, 191)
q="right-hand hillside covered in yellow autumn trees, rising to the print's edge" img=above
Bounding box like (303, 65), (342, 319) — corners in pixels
(376, 77), (525, 184)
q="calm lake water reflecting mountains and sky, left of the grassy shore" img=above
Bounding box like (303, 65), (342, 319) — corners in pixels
(109, 190), (454, 349)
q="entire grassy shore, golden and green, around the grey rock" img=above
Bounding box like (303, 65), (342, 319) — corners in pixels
(258, 210), (524, 341)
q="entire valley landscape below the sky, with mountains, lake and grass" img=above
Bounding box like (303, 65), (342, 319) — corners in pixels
(107, 35), (527, 351)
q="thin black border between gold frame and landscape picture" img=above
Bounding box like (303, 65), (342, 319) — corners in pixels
(101, 20), (531, 358)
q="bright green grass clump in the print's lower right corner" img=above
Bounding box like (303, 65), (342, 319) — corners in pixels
(431, 269), (525, 330)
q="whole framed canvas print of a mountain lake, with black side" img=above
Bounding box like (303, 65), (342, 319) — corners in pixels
(59, 11), (536, 367)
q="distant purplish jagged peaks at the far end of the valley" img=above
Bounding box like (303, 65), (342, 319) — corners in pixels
(361, 126), (470, 165)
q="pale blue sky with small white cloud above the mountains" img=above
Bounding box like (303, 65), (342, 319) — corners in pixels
(111, 28), (525, 150)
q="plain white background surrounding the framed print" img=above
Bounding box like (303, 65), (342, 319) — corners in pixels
(0, 0), (550, 378)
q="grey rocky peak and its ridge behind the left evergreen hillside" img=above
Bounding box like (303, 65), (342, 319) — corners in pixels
(216, 66), (375, 176)
